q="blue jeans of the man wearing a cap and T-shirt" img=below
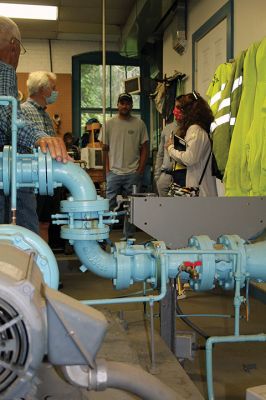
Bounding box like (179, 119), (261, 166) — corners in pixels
(106, 171), (142, 238)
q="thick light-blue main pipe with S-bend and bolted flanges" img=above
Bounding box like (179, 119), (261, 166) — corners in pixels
(0, 144), (266, 294)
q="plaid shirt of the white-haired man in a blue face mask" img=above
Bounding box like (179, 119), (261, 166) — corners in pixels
(21, 98), (55, 136)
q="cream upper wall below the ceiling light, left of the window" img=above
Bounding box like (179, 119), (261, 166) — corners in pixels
(17, 39), (118, 74)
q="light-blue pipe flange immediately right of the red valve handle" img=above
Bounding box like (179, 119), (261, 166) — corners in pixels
(188, 235), (215, 290)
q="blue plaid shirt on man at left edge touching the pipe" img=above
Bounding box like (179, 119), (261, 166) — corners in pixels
(0, 61), (47, 153)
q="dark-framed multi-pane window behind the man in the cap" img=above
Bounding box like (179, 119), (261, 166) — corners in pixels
(72, 52), (149, 137)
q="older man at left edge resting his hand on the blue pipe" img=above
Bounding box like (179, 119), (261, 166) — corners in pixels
(0, 16), (69, 233)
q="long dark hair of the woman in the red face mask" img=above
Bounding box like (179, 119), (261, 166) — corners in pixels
(178, 91), (214, 137)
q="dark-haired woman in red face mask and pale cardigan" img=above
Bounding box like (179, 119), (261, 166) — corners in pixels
(166, 92), (217, 196)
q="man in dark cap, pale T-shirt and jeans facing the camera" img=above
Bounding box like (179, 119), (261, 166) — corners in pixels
(99, 93), (149, 239)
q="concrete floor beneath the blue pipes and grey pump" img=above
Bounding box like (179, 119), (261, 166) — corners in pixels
(40, 231), (266, 400)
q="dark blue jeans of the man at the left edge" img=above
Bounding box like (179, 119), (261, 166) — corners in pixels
(0, 188), (39, 234)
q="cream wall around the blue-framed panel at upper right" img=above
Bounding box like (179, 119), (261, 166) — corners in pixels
(163, 0), (266, 92)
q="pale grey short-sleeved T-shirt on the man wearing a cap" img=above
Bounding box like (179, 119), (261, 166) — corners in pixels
(99, 116), (149, 175)
